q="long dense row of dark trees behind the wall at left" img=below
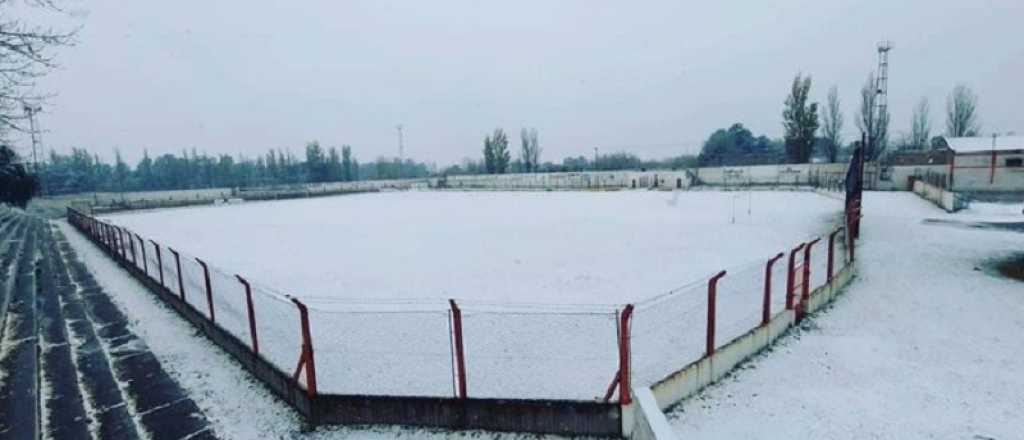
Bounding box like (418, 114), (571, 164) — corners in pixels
(40, 141), (432, 194)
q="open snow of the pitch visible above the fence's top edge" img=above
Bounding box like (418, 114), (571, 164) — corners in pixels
(101, 191), (842, 304)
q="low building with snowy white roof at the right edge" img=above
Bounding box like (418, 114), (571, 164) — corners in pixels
(933, 136), (1024, 192)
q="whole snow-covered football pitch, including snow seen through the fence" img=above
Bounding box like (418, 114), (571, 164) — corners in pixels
(105, 190), (843, 400)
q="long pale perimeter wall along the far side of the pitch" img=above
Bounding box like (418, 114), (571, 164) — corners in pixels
(41, 163), (983, 217)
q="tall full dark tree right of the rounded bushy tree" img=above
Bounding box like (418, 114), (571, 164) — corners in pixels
(782, 75), (818, 164)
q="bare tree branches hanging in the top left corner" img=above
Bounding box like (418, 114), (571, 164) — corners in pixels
(0, 0), (74, 136)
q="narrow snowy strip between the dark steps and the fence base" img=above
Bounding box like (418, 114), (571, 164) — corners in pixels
(59, 222), (598, 440)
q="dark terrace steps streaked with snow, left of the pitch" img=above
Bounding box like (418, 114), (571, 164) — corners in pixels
(0, 212), (215, 440)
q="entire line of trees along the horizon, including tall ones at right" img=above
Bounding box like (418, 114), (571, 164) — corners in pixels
(14, 75), (980, 199)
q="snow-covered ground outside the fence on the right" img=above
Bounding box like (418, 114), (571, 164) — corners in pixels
(669, 192), (1024, 439)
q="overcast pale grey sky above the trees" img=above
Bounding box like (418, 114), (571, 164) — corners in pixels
(14, 0), (1024, 165)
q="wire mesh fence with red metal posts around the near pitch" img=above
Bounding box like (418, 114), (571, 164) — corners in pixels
(68, 209), (852, 403)
